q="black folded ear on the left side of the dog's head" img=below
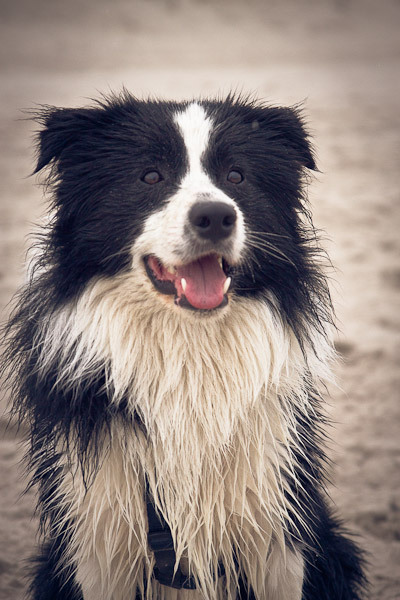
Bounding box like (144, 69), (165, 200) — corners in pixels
(34, 106), (94, 173)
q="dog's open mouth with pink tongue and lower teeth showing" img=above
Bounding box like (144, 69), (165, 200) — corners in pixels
(144, 254), (232, 310)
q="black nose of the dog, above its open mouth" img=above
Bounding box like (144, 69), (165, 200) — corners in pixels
(189, 202), (237, 243)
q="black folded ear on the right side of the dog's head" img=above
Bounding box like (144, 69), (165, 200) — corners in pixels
(266, 107), (317, 170)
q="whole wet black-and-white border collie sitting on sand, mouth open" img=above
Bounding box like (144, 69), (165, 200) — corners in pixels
(3, 91), (364, 600)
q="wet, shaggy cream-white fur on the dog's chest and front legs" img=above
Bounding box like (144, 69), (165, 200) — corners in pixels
(36, 275), (332, 600)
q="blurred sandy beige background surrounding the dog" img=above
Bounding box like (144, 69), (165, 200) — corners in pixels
(0, 0), (400, 600)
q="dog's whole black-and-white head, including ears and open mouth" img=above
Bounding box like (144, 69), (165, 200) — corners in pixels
(33, 95), (314, 314)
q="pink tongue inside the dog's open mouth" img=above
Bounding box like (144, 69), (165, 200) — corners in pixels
(176, 255), (226, 309)
